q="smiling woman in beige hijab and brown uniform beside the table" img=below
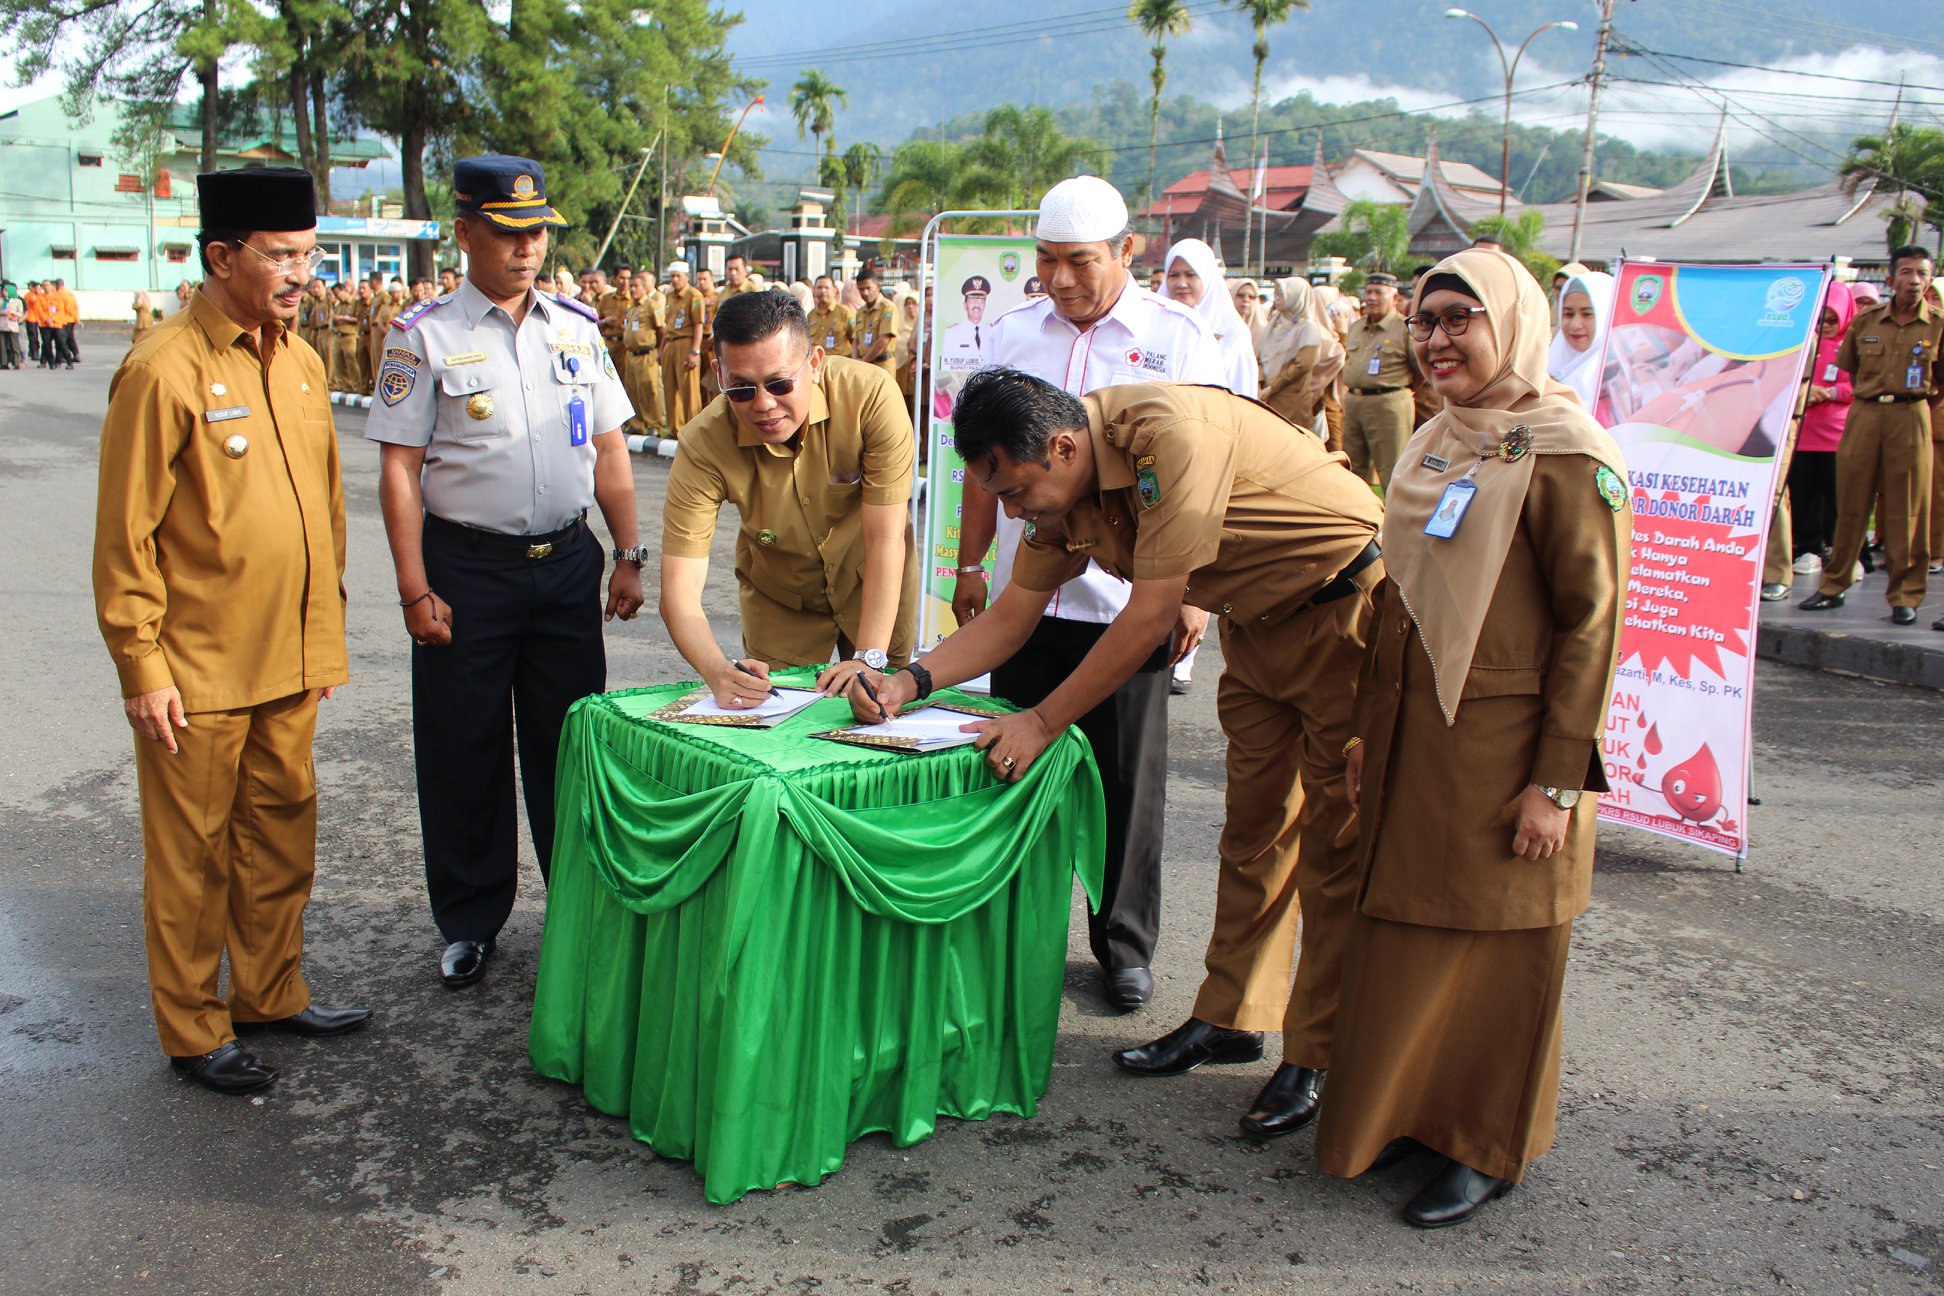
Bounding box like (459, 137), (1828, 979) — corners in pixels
(1316, 249), (1631, 1228)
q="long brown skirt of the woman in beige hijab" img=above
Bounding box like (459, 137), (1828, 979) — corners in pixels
(1316, 913), (1573, 1181)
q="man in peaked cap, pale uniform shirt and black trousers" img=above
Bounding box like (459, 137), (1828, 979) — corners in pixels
(365, 155), (647, 989)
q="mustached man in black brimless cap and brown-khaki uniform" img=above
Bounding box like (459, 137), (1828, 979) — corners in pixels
(93, 167), (369, 1094)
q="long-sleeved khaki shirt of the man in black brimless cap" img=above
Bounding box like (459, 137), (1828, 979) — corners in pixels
(93, 293), (348, 711)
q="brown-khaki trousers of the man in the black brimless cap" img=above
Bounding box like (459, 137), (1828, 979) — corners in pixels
(134, 690), (317, 1057)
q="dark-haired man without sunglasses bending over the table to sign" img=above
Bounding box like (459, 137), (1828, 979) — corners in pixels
(851, 369), (1384, 1139)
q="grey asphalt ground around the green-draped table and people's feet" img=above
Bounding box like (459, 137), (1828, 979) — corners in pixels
(0, 328), (1944, 1296)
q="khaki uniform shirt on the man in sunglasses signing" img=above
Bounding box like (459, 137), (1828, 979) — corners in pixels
(661, 356), (913, 617)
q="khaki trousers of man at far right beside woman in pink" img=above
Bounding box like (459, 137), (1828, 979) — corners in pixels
(1822, 400), (1930, 608)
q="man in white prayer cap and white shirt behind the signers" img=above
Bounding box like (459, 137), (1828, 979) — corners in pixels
(953, 175), (1223, 1010)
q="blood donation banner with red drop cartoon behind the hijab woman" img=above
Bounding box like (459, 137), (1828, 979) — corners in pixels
(1598, 260), (1827, 859)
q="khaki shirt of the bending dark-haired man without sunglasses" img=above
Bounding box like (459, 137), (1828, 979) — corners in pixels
(1013, 383), (1382, 621)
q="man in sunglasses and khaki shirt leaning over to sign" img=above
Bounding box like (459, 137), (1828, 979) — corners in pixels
(661, 293), (918, 707)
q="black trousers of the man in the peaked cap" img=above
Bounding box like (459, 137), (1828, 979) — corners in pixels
(412, 519), (607, 940)
